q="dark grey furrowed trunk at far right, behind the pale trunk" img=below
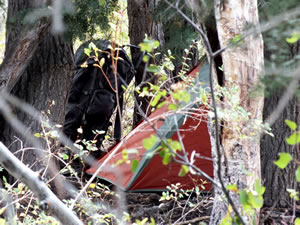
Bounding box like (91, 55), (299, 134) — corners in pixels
(261, 42), (300, 208)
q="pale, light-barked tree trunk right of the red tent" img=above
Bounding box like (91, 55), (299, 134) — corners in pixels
(210, 0), (263, 224)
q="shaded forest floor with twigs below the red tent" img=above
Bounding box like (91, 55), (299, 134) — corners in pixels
(72, 178), (300, 225)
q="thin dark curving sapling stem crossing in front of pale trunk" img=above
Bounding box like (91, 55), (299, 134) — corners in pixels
(164, 0), (246, 225)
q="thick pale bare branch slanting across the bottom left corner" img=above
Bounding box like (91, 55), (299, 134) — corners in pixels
(0, 142), (83, 225)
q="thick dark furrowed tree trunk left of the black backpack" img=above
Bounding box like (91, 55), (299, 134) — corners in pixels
(0, 0), (74, 169)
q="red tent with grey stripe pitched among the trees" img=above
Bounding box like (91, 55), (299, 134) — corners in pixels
(86, 63), (213, 192)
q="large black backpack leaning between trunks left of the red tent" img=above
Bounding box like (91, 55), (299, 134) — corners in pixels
(63, 40), (135, 157)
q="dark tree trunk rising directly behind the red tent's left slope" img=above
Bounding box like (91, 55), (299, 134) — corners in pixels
(127, 0), (164, 126)
